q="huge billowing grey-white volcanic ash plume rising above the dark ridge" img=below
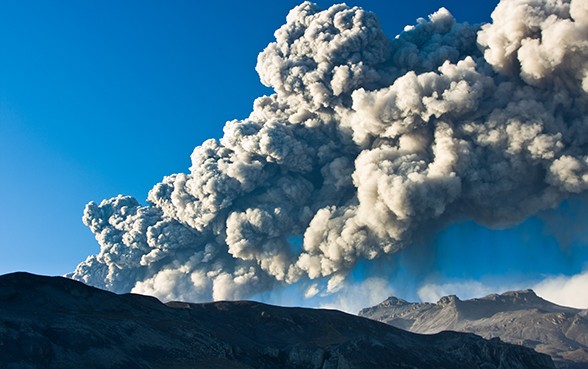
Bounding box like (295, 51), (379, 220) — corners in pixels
(70, 0), (588, 300)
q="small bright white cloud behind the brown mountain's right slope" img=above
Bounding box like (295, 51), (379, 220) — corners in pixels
(533, 271), (588, 309)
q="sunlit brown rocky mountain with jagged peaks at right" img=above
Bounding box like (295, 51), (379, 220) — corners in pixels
(359, 290), (588, 369)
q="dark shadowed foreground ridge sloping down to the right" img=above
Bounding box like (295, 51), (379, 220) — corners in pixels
(0, 273), (554, 369)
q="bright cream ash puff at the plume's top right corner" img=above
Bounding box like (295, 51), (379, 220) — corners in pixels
(478, 0), (588, 91)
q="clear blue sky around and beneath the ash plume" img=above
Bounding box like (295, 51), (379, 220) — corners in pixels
(0, 0), (588, 304)
